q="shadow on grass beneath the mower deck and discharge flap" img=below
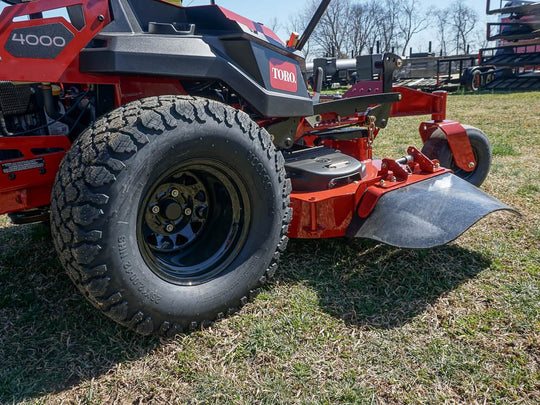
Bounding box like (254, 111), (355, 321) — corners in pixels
(280, 239), (491, 329)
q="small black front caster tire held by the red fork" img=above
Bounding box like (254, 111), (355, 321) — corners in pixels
(422, 125), (492, 187)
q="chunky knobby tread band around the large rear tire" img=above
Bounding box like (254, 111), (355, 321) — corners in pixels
(51, 96), (292, 337)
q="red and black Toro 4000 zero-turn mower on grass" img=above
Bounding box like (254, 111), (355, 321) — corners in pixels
(0, 0), (510, 336)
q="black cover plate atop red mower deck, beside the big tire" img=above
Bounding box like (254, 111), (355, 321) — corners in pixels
(283, 146), (366, 191)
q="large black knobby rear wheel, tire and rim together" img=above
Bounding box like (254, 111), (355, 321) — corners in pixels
(51, 96), (292, 336)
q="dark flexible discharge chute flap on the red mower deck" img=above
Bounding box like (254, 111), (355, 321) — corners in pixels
(347, 173), (519, 248)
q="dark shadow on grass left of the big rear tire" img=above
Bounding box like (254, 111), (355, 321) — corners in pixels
(0, 225), (159, 403)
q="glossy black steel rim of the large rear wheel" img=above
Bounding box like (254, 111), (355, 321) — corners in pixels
(137, 159), (251, 285)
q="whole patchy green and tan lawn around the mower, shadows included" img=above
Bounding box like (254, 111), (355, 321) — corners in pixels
(0, 93), (540, 404)
